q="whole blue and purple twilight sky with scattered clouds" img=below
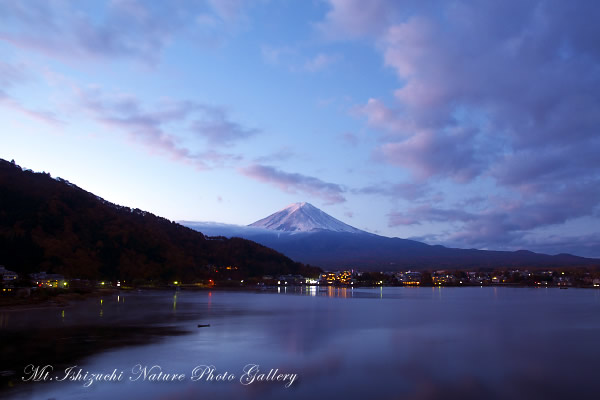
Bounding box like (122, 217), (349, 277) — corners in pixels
(0, 0), (600, 257)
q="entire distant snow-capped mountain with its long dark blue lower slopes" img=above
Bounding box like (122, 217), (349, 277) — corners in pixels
(181, 203), (600, 270)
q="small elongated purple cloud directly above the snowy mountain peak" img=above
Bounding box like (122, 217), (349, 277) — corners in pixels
(240, 164), (346, 204)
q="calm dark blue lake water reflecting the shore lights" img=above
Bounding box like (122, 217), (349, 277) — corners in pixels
(0, 287), (600, 400)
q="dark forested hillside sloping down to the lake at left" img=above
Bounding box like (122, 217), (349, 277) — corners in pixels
(0, 159), (318, 282)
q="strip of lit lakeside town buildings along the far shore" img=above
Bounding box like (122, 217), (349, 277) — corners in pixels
(0, 265), (600, 297)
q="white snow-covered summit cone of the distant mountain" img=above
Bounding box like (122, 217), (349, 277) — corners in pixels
(249, 203), (363, 233)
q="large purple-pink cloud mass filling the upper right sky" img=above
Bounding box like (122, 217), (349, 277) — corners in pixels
(356, 1), (600, 187)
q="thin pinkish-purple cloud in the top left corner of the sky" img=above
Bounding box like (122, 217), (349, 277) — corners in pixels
(0, 0), (244, 64)
